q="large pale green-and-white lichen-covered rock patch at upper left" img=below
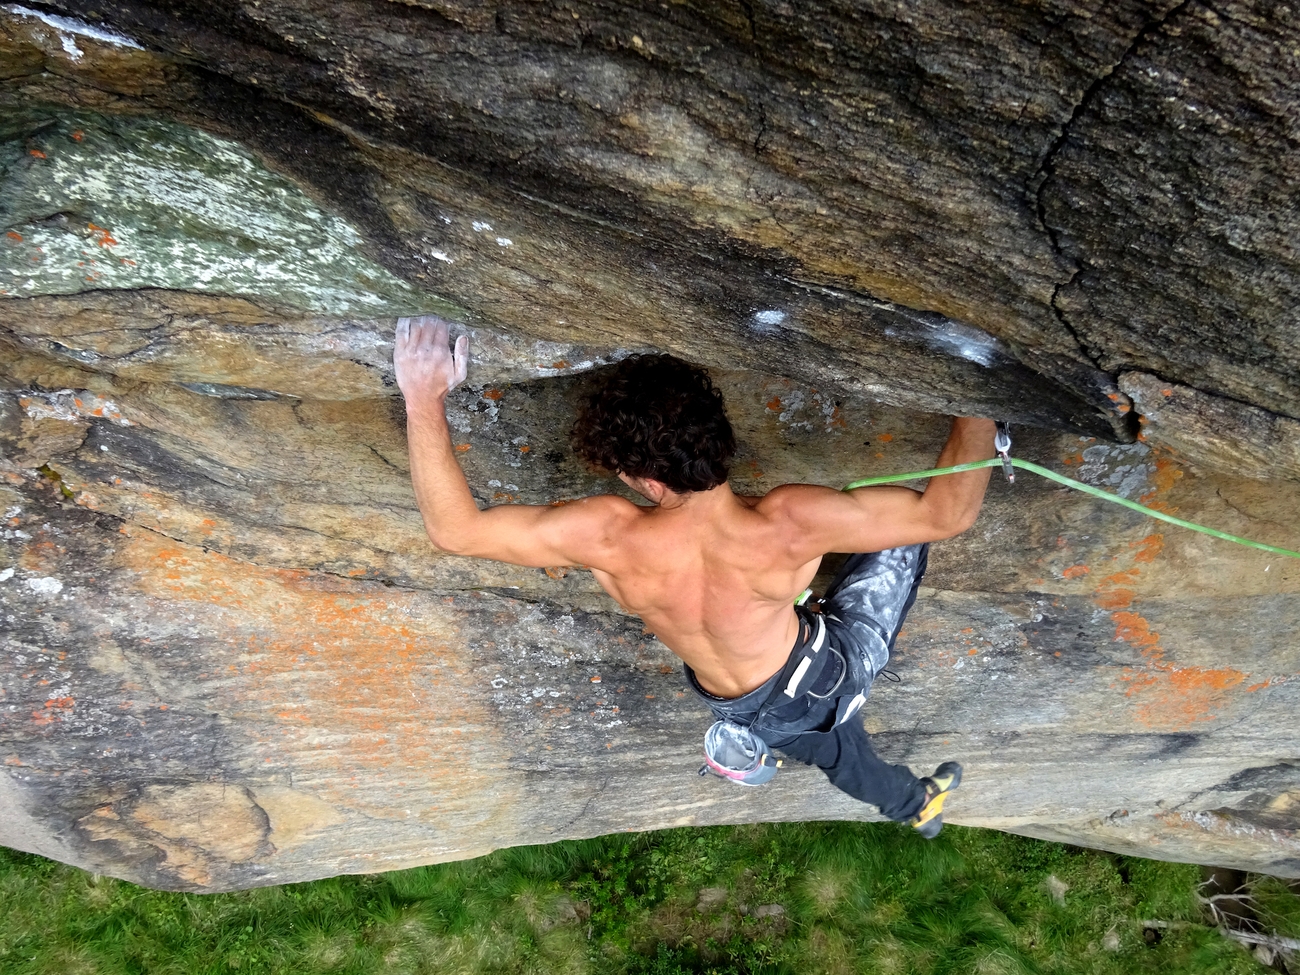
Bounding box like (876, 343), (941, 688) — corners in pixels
(0, 113), (430, 316)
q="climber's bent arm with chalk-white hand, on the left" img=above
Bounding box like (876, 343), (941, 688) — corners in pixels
(394, 319), (636, 568)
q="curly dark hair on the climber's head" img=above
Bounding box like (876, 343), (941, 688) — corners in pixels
(572, 355), (736, 494)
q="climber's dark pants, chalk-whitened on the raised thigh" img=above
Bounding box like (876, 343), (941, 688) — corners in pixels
(686, 545), (930, 820)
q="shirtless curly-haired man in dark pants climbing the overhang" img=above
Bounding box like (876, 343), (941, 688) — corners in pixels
(395, 319), (995, 837)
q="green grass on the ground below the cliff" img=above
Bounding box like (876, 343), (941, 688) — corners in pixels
(0, 823), (1284, 975)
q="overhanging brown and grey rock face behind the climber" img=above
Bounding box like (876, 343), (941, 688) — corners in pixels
(0, 0), (1300, 891)
